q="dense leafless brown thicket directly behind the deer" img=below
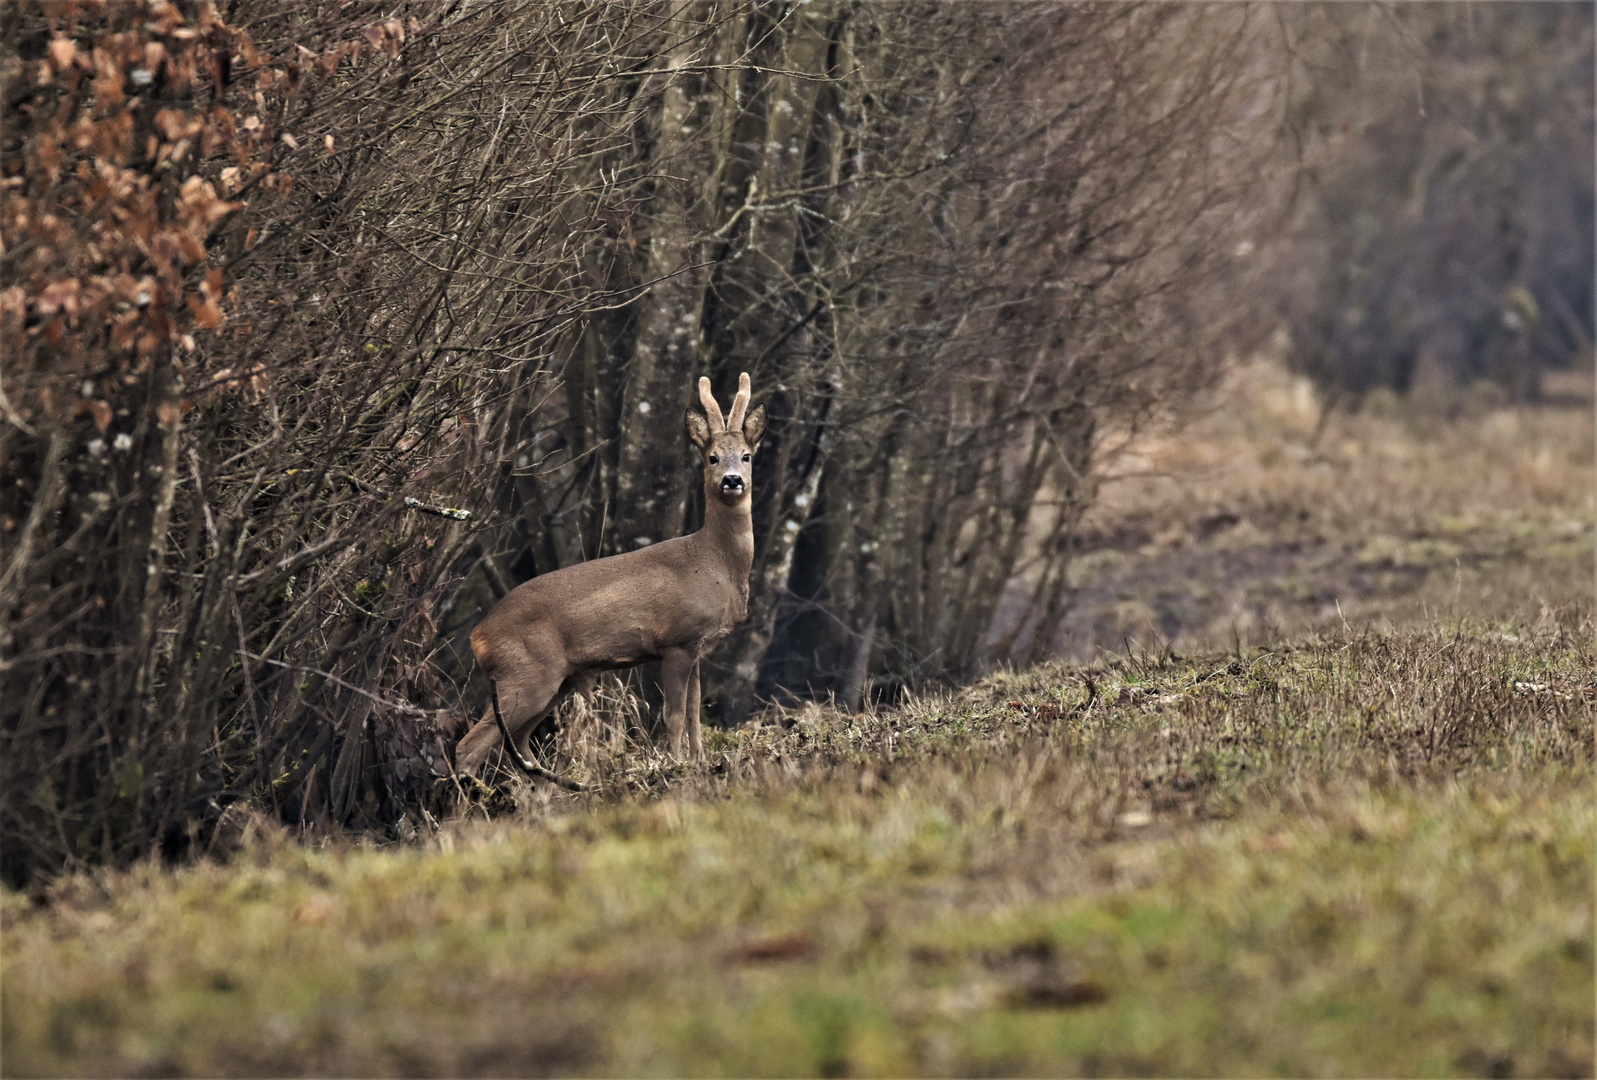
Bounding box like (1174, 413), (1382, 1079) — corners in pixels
(0, 0), (1279, 880)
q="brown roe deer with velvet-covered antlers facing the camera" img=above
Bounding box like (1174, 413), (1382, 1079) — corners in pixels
(455, 374), (765, 786)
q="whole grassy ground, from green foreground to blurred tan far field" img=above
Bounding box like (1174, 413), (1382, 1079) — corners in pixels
(0, 371), (1597, 1075)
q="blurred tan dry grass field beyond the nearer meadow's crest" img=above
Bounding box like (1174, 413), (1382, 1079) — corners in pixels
(1056, 361), (1597, 660)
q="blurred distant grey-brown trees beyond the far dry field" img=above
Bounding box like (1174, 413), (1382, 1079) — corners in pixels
(1262, 3), (1597, 401)
